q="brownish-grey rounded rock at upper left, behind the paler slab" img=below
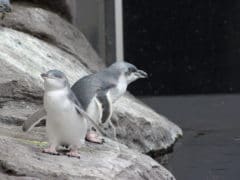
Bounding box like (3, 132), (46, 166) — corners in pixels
(0, 3), (105, 71)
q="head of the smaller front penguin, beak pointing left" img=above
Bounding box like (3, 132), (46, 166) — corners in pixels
(41, 70), (69, 90)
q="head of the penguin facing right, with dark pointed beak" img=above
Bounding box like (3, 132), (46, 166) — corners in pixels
(109, 62), (148, 84)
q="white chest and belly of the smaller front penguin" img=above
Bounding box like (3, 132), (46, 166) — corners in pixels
(44, 90), (87, 144)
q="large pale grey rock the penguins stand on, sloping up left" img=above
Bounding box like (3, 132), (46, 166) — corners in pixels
(0, 28), (175, 180)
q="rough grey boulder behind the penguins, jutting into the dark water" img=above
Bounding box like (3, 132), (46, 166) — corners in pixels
(112, 95), (182, 153)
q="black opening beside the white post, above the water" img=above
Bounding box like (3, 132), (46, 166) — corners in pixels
(123, 0), (240, 95)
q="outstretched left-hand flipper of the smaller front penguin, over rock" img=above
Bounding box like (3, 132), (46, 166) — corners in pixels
(22, 108), (47, 132)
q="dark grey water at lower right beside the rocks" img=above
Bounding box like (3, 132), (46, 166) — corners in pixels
(142, 95), (240, 180)
